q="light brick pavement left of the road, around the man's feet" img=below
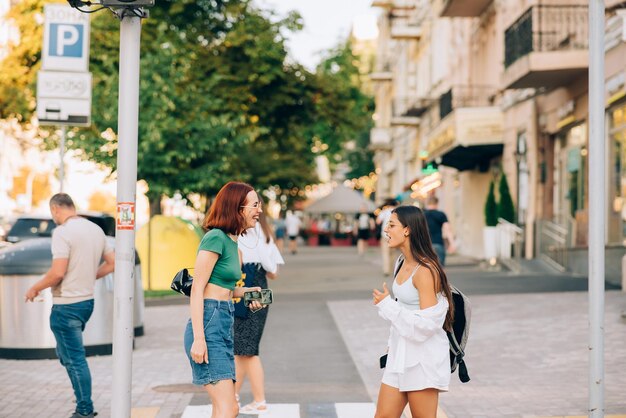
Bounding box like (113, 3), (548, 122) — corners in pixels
(0, 305), (193, 418)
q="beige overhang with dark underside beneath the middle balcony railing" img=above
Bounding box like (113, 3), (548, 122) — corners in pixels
(427, 107), (504, 171)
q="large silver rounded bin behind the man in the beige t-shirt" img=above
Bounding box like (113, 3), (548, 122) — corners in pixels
(0, 237), (144, 359)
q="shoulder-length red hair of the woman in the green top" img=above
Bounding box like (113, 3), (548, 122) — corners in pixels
(202, 181), (254, 235)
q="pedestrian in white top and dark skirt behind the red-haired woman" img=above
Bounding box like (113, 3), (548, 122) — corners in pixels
(235, 207), (285, 414)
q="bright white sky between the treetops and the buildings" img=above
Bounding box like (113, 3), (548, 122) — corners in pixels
(256, 0), (378, 70)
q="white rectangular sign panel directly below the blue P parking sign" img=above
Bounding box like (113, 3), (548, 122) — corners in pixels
(37, 71), (91, 126)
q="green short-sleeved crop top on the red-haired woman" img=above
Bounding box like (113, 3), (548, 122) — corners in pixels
(198, 229), (241, 290)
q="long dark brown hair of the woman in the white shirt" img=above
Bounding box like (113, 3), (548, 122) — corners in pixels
(391, 206), (454, 331)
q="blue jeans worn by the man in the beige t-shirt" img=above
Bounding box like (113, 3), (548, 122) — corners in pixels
(50, 299), (93, 415)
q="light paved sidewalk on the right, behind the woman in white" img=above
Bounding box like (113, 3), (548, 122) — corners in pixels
(328, 291), (626, 418)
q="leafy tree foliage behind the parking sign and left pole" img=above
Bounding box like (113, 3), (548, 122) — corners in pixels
(0, 0), (372, 204)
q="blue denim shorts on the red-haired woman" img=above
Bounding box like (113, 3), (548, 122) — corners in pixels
(185, 299), (235, 385)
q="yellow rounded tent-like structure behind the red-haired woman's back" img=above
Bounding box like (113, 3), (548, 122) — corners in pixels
(135, 215), (202, 290)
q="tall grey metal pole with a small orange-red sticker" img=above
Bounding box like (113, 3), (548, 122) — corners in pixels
(111, 9), (141, 418)
